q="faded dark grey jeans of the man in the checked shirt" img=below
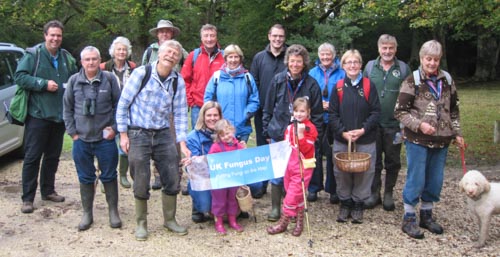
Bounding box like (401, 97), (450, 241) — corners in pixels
(127, 128), (180, 200)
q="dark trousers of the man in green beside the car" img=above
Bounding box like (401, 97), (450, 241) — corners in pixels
(21, 115), (65, 202)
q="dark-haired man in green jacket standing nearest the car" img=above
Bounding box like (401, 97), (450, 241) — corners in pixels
(15, 20), (77, 213)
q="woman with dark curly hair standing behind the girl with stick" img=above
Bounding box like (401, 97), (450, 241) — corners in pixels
(262, 45), (323, 231)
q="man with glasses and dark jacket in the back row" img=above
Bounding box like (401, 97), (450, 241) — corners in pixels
(250, 24), (286, 199)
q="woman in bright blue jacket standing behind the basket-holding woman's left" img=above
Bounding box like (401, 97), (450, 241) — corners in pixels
(307, 43), (345, 204)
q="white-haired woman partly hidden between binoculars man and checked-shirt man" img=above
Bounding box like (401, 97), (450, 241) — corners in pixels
(99, 37), (136, 188)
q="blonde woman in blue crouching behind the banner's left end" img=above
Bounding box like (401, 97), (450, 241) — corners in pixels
(186, 101), (222, 223)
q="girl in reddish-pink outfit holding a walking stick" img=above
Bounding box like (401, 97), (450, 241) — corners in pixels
(267, 97), (318, 236)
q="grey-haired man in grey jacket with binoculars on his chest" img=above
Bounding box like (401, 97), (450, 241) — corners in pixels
(63, 46), (122, 230)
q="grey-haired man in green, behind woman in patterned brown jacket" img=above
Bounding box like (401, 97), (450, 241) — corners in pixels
(363, 34), (410, 211)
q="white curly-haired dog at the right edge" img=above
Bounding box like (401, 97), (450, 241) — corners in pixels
(459, 170), (500, 247)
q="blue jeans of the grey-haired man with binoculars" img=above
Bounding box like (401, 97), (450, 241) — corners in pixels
(73, 139), (118, 184)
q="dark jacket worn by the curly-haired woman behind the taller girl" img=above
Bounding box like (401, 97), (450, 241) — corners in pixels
(262, 69), (323, 141)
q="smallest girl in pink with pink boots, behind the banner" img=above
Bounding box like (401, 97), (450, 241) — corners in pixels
(208, 119), (245, 235)
